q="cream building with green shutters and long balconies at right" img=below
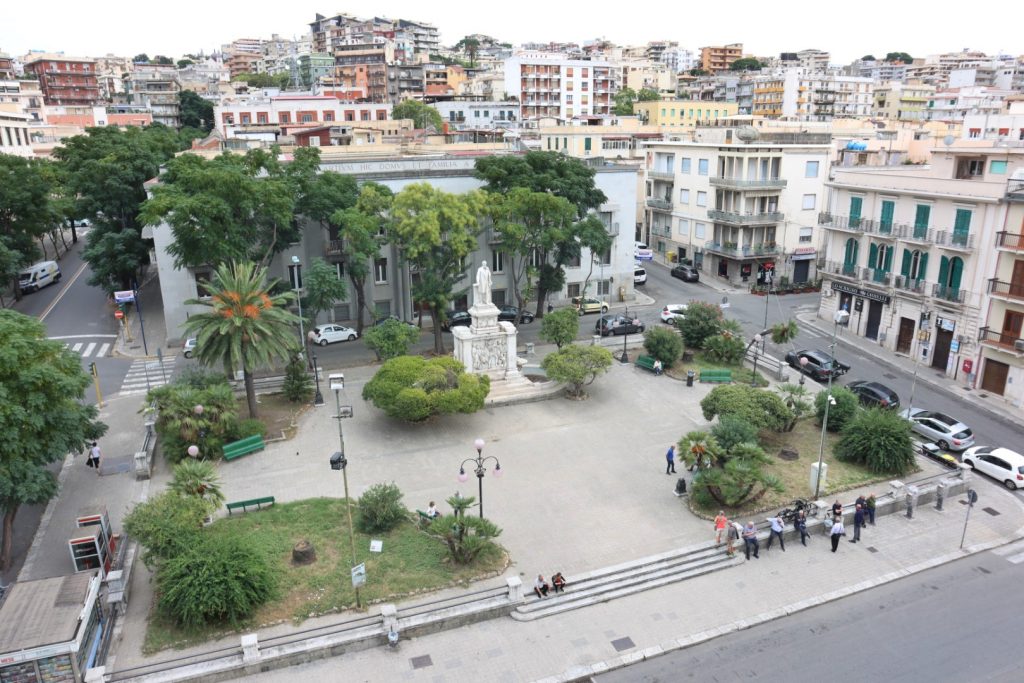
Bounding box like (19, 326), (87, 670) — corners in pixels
(818, 145), (1024, 382)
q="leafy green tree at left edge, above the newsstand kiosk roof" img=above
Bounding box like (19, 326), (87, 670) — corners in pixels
(0, 310), (106, 568)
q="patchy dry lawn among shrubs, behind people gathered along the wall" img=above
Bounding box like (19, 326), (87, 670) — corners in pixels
(691, 418), (905, 516)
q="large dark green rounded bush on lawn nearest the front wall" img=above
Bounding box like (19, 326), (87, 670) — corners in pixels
(157, 537), (276, 629)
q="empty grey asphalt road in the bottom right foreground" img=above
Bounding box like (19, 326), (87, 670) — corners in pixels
(593, 542), (1024, 683)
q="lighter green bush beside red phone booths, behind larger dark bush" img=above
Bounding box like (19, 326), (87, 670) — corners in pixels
(124, 492), (208, 569)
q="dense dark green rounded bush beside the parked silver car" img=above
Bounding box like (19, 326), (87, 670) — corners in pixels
(828, 408), (914, 475)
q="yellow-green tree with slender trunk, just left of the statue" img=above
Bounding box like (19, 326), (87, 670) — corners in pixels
(390, 182), (486, 353)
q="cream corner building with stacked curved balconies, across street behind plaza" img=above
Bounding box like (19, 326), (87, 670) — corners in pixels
(645, 127), (831, 286)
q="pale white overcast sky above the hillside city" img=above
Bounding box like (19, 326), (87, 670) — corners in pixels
(0, 0), (1024, 63)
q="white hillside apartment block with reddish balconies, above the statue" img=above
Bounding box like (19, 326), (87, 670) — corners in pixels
(504, 51), (620, 120)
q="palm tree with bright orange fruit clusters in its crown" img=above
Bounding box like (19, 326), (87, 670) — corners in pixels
(185, 262), (299, 418)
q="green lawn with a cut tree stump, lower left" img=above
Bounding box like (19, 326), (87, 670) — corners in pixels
(143, 498), (506, 653)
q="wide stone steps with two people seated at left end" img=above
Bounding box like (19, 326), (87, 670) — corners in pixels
(511, 542), (743, 622)
